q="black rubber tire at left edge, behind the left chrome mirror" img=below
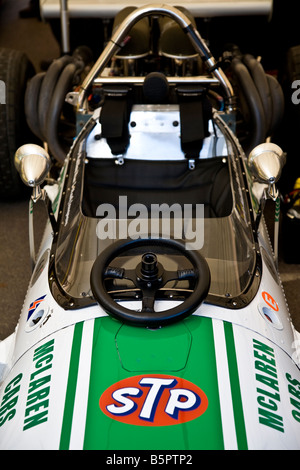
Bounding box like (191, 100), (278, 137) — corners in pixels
(0, 48), (34, 200)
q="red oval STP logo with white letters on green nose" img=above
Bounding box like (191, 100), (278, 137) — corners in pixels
(99, 374), (208, 426)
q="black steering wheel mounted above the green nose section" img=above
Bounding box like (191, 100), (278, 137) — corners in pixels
(91, 238), (210, 327)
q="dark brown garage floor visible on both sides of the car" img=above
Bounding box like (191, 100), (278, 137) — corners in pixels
(0, 0), (300, 340)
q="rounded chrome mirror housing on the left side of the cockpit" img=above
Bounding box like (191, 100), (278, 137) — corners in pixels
(15, 144), (51, 188)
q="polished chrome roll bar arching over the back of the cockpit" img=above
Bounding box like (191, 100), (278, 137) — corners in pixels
(77, 4), (233, 114)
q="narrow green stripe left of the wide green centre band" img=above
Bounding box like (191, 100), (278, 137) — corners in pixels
(59, 322), (83, 450)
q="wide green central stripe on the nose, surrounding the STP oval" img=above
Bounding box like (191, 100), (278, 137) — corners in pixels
(83, 315), (224, 451)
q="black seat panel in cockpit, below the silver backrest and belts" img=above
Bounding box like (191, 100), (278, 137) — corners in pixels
(82, 157), (232, 217)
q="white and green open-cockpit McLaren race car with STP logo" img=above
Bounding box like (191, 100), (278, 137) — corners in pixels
(0, 4), (300, 452)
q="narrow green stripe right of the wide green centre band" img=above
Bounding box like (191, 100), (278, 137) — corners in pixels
(224, 322), (248, 450)
